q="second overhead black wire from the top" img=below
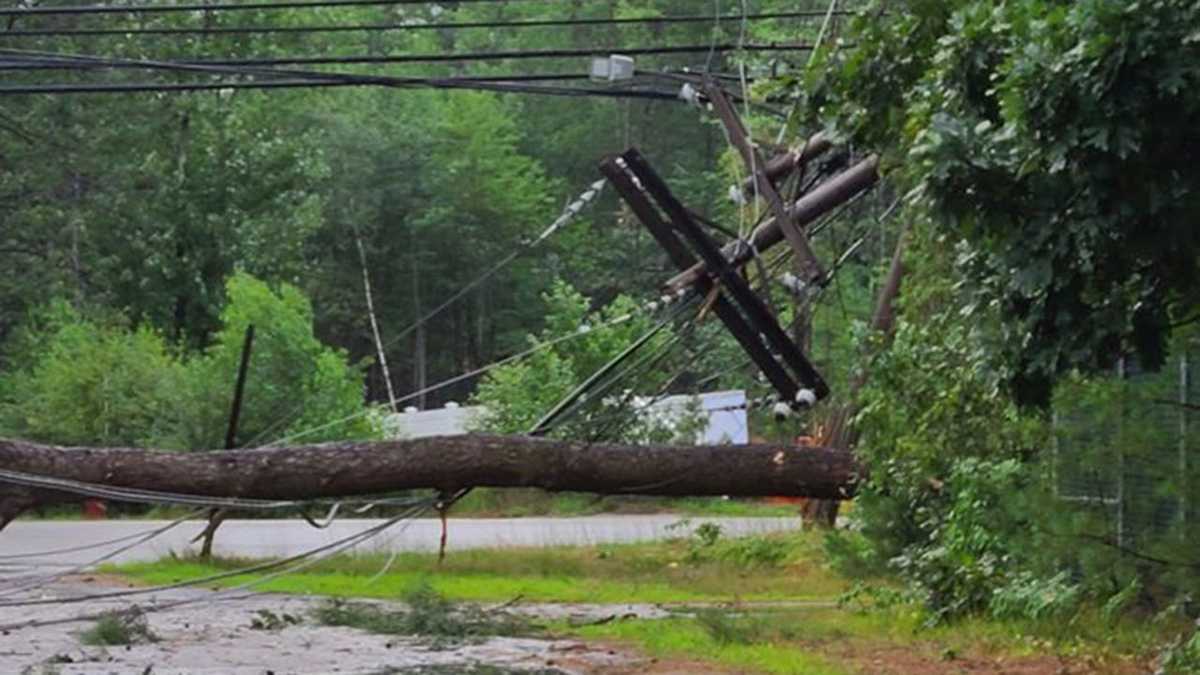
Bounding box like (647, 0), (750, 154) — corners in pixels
(0, 10), (856, 38)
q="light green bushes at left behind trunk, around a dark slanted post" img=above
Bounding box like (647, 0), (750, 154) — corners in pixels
(0, 274), (379, 449)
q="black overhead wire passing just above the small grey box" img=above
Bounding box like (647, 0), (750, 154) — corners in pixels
(0, 43), (812, 71)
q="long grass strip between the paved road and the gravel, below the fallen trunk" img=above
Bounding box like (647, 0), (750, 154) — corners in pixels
(108, 533), (847, 603)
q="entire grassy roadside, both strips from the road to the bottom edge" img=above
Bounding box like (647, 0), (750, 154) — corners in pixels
(108, 527), (1160, 675)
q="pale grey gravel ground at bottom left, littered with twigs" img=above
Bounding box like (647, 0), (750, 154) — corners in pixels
(0, 577), (653, 675)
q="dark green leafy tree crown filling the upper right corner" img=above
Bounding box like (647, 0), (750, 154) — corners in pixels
(808, 0), (1200, 406)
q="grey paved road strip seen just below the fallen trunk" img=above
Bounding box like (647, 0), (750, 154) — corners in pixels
(0, 514), (800, 566)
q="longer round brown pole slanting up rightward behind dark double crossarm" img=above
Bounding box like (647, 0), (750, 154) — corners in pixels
(664, 155), (880, 291)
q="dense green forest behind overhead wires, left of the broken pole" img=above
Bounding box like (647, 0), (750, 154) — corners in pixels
(0, 0), (844, 408)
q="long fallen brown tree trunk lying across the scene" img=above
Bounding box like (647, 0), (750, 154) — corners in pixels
(0, 435), (858, 527)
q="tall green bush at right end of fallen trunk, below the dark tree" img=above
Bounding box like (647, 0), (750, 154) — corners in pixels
(828, 222), (1048, 621)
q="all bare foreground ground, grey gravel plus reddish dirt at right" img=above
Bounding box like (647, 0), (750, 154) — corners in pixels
(0, 575), (1147, 675)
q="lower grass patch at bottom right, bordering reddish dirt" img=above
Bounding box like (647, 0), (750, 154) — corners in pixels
(568, 607), (1163, 674)
